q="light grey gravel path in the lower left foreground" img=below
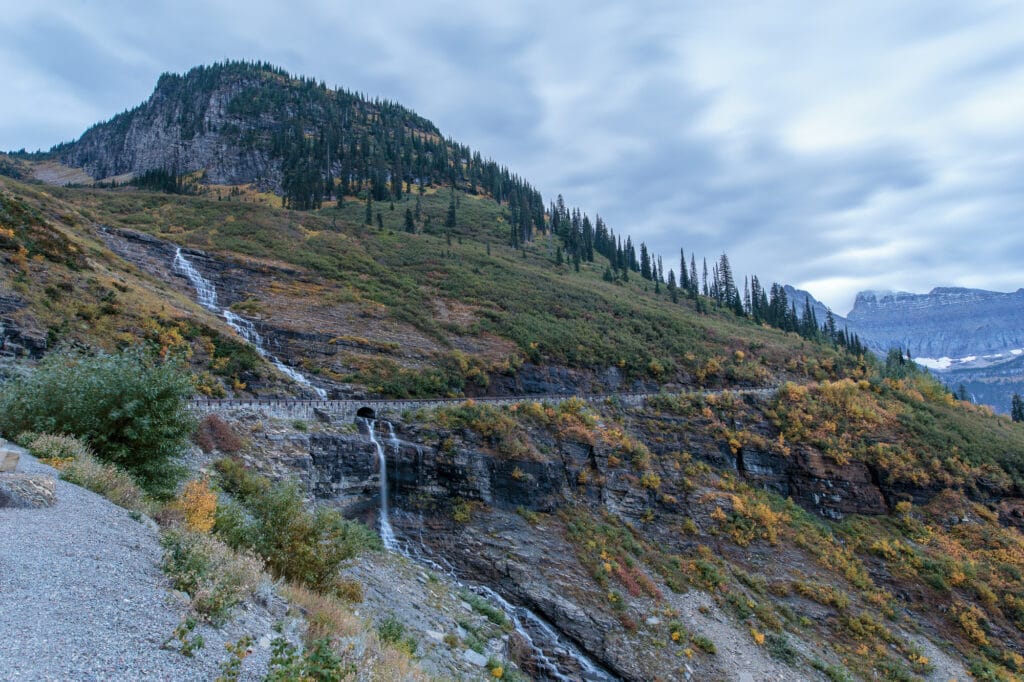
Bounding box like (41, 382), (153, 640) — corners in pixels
(0, 454), (284, 681)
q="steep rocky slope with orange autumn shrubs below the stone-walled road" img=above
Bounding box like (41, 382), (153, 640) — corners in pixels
(216, 372), (1024, 680)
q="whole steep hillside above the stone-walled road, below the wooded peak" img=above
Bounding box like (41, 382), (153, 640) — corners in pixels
(2, 174), (858, 396)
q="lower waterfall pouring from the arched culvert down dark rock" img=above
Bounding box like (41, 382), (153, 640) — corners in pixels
(356, 417), (618, 682)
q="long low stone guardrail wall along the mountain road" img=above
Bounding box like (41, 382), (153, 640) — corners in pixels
(189, 388), (775, 421)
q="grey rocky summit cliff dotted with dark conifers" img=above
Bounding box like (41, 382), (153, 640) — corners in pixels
(53, 62), (443, 196)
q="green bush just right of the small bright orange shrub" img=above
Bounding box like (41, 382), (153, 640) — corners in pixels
(214, 460), (381, 592)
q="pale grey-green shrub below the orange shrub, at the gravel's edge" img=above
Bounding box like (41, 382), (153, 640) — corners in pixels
(161, 530), (263, 624)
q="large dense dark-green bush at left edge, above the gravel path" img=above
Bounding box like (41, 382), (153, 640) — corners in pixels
(0, 349), (195, 497)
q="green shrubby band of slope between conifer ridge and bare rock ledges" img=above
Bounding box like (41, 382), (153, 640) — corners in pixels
(29, 178), (853, 391)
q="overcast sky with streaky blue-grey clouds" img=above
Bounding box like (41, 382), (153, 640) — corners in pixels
(0, 0), (1024, 314)
